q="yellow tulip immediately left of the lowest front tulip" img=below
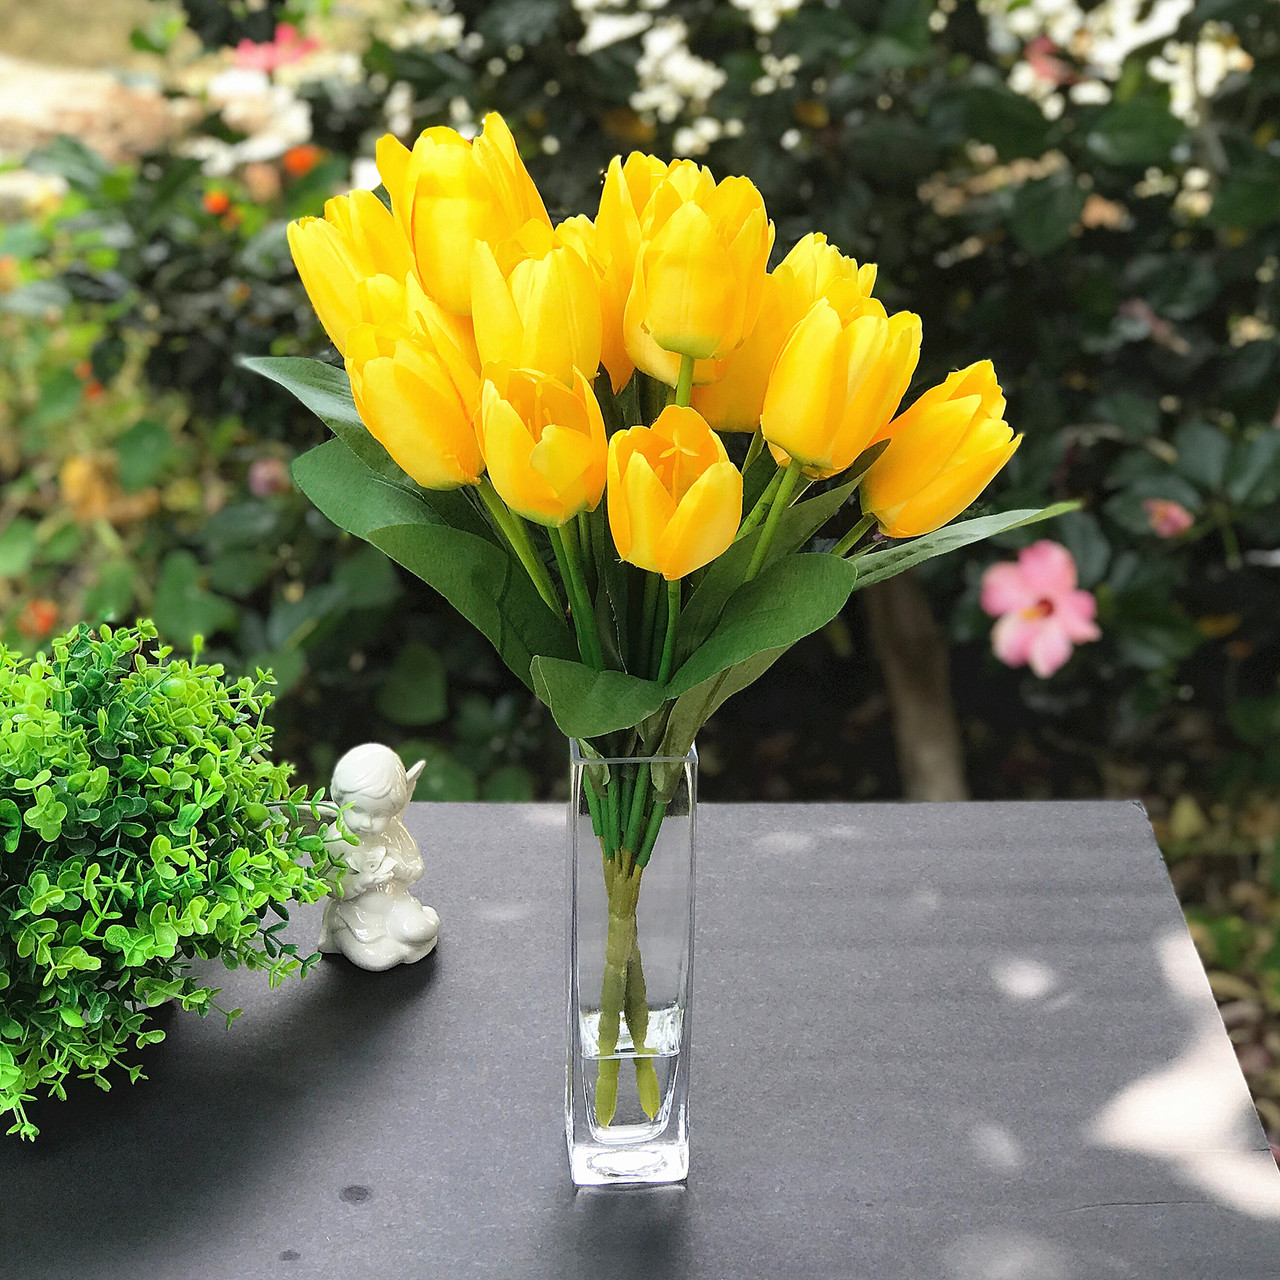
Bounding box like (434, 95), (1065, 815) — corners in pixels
(479, 365), (608, 527)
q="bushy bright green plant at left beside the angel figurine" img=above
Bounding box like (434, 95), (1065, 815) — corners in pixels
(0, 622), (333, 1138)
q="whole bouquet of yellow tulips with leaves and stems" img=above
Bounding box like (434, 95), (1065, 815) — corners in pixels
(250, 115), (1061, 1125)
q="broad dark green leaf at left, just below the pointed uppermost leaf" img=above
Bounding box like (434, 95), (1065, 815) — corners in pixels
(293, 440), (576, 687)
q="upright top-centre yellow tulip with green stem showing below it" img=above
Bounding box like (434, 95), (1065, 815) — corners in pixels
(623, 160), (773, 383)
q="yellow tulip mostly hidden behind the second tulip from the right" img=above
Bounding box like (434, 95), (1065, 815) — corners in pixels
(692, 232), (876, 431)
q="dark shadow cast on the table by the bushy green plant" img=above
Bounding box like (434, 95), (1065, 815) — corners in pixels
(0, 952), (444, 1276)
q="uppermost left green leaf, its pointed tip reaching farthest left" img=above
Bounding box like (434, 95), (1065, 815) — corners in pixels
(241, 356), (497, 541)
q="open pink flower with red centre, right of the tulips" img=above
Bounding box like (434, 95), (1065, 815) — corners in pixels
(982, 539), (1102, 680)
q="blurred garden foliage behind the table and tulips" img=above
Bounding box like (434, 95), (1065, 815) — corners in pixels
(0, 0), (1280, 1134)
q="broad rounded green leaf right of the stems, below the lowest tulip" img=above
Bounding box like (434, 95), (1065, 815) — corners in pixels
(667, 554), (858, 696)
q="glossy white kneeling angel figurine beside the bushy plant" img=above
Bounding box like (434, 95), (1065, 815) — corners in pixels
(317, 742), (440, 970)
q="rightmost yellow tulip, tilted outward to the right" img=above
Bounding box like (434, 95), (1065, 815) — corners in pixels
(861, 360), (1023, 538)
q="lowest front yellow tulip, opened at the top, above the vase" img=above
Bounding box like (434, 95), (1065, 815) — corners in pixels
(608, 404), (742, 581)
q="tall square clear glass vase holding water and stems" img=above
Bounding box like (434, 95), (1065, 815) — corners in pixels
(564, 742), (698, 1187)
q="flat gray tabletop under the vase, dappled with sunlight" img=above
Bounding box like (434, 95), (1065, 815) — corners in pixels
(0, 803), (1280, 1280)
